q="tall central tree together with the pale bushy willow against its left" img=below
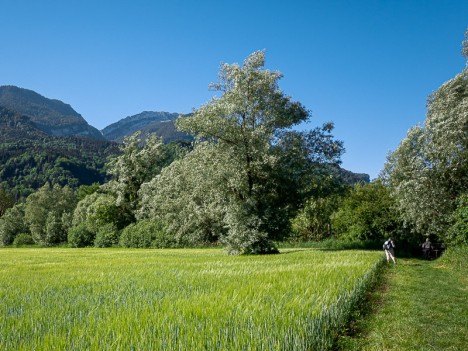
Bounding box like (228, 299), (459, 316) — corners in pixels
(141, 51), (342, 253)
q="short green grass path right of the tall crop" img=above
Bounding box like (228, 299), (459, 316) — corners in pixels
(340, 248), (468, 351)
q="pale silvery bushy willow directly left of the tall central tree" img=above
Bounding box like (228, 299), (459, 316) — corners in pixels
(138, 143), (227, 245)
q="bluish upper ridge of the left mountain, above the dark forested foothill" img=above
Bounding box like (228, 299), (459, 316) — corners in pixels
(0, 85), (104, 140)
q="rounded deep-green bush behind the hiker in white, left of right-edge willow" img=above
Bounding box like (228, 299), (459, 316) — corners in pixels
(332, 181), (403, 240)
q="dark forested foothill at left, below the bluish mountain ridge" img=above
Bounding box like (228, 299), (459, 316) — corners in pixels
(0, 106), (119, 197)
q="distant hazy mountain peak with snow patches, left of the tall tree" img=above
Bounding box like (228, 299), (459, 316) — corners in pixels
(101, 111), (192, 143)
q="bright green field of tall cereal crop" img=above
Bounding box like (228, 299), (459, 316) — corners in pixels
(0, 248), (382, 351)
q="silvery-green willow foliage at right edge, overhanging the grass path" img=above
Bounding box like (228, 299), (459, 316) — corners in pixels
(382, 69), (468, 239)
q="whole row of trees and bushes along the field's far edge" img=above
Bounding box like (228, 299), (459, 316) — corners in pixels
(0, 44), (468, 254)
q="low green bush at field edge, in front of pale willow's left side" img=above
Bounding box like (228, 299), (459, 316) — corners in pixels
(119, 220), (175, 248)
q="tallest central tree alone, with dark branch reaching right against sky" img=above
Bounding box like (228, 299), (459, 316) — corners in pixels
(171, 51), (342, 253)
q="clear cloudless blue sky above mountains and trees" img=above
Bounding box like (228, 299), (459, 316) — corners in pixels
(0, 0), (468, 178)
